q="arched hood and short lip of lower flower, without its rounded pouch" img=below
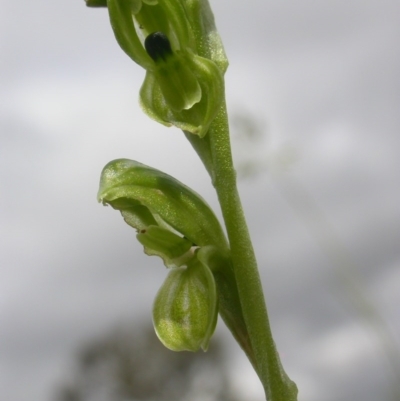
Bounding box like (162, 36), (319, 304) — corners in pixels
(98, 159), (229, 267)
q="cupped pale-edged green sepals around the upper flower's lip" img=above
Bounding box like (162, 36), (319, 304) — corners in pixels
(140, 53), (224, 138)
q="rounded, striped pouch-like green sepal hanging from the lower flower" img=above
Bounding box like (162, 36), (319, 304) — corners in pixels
(153, 253), (218, 352)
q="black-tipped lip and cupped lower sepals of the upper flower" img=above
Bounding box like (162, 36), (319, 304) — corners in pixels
(140, 32), (224, 138)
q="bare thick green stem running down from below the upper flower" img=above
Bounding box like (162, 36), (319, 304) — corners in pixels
(200, 104), (297, 401)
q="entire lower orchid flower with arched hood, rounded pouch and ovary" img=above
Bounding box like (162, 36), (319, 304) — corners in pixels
(98, 159), (252, 356)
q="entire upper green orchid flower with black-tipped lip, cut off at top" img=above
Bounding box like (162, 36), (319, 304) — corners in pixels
(86, 0), (227, 137)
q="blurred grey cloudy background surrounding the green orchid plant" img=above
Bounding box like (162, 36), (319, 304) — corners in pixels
(0, 0), (400, 401)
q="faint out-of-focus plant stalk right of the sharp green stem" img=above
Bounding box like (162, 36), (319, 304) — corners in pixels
(231, 111), (400, 401)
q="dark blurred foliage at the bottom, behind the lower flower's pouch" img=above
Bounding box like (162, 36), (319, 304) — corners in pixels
(55, 326), (238, 401)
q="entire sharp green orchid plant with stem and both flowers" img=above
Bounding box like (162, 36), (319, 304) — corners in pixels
(86, 0), (297, 401)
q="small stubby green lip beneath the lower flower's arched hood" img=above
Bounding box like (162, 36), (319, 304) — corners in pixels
(136, 226), (192, 267)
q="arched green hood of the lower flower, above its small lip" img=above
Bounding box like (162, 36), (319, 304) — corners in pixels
(98, 159), (228, 253)
